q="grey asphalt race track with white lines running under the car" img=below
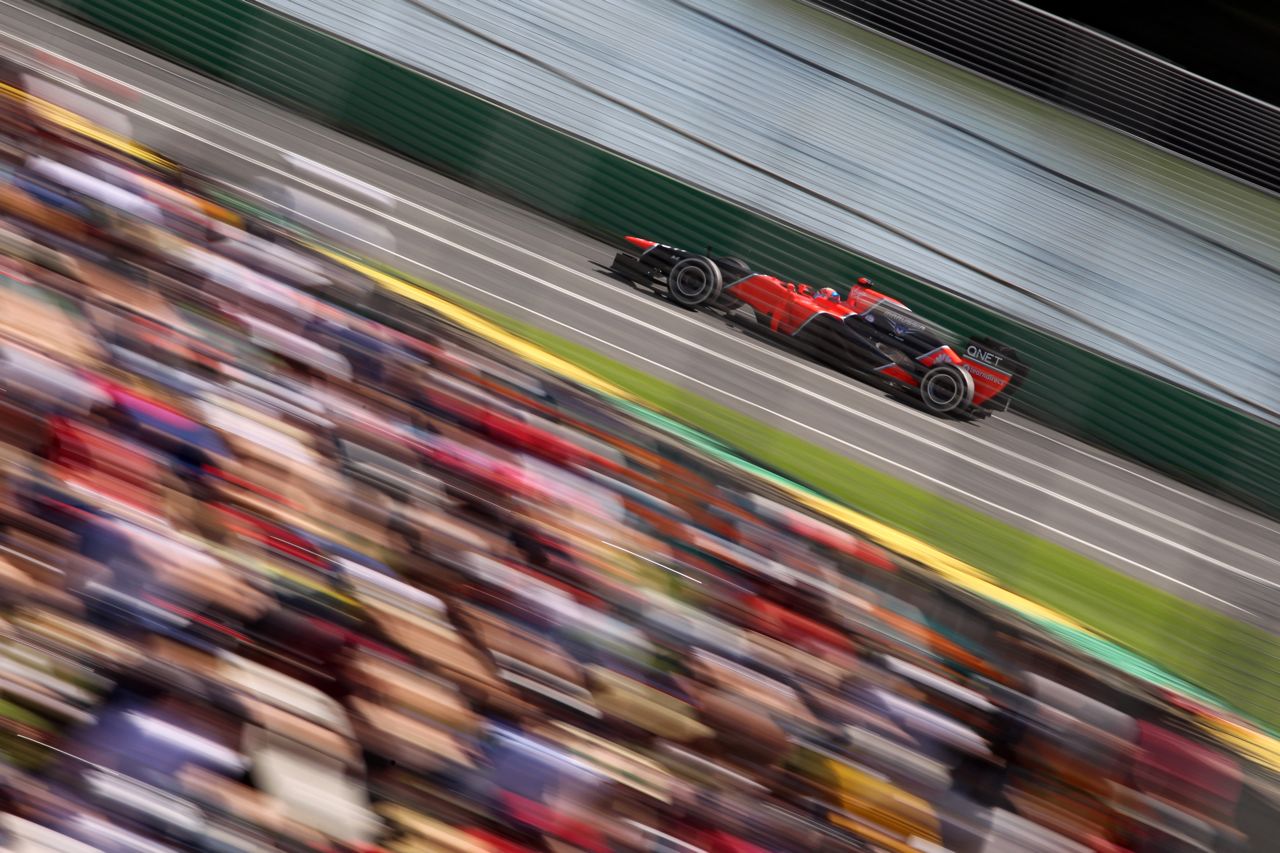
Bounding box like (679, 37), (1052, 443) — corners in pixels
(10, 0), (1280, 630)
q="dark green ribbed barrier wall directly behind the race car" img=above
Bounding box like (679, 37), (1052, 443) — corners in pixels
(46, 0), (1280, 517)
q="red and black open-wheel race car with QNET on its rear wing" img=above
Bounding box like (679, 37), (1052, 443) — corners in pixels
(611, 237), (1027, 420)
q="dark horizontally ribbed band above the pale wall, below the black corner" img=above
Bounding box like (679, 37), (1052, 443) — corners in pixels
(804, 0), (1280, 192)
